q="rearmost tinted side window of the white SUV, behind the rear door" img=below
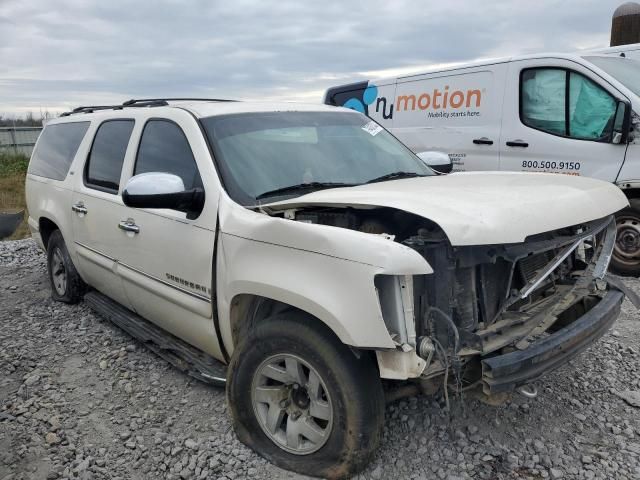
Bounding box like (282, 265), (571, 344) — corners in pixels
(28, 122), (90, 180)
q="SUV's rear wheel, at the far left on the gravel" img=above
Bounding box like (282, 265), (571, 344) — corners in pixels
(47, 230), (87, 303)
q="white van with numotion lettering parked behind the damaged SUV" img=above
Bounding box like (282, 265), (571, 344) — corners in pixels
(324, 45), (640, 274)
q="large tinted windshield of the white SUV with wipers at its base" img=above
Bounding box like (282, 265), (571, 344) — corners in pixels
(202, 111), (434, 205)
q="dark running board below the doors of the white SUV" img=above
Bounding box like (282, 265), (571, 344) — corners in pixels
(84, 291), (227, 387)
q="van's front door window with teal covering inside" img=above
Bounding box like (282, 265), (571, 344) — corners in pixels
(520, 68), (617, 141)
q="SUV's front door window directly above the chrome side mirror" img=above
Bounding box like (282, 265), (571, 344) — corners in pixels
(133, 120), (202, 190)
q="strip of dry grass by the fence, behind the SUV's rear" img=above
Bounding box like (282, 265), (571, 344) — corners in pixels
(0, 153), (30, 240)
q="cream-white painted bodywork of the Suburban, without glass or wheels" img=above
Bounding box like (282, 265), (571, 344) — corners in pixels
(26, 103), (626, 378)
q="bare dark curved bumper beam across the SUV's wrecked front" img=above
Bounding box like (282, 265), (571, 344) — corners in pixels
(482, 290), (624, 395)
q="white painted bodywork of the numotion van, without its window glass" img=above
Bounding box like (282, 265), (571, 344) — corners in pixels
(325, 44), (640, 189)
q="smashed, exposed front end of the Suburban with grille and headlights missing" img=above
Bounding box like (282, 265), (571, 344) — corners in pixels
(403, 216), (624, 395)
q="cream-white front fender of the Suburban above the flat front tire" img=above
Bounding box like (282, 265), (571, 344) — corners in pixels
(217, 197), (433, 352)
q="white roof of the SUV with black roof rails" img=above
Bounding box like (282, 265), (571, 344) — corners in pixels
(54, 99), (347, 121)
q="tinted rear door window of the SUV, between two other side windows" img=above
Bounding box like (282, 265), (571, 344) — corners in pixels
(85, 120), (134, 193)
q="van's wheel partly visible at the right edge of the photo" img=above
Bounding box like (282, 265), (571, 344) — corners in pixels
(611, 198), (640, 276)
